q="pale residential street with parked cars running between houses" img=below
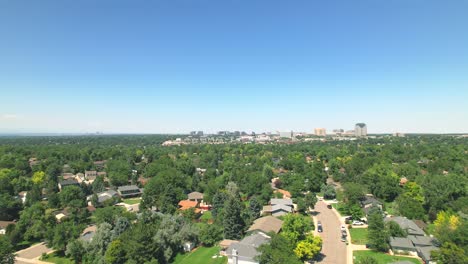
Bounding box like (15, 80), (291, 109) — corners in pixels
(315, 201), (347, 264)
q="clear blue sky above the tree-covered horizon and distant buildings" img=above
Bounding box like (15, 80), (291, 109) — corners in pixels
(0, 0), (468, 133)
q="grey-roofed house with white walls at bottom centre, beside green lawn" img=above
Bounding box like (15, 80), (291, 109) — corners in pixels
(226, 232), (271, 264)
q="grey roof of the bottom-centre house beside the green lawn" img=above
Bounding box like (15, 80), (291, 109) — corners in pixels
(226, 232), (270, 262)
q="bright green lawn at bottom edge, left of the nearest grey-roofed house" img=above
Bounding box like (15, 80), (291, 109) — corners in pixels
(173, 246), (227, 264)
